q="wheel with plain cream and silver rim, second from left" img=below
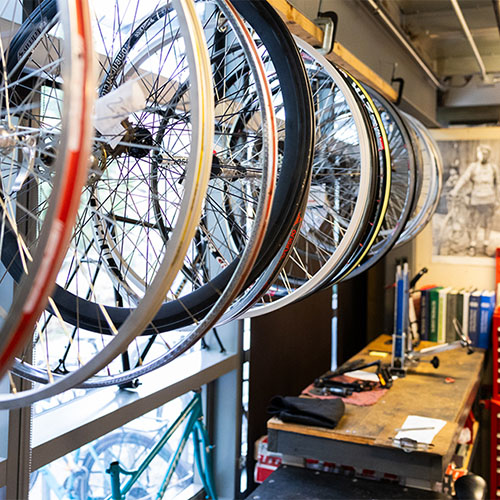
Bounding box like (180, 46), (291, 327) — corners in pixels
(0, 0), (213, 407)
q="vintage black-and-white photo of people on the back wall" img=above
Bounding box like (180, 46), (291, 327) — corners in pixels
(431, 127), (500, 264)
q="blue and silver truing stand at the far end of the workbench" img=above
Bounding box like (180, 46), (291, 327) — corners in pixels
(391, 261), (473, 377)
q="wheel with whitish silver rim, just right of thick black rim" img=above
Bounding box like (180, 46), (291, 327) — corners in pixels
(217, 39), (378, 318)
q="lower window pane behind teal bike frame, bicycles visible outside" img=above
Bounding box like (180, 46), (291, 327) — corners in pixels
(30, 394), (194, 500)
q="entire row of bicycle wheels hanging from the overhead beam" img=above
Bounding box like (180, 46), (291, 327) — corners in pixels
(0, 0), (441, 408)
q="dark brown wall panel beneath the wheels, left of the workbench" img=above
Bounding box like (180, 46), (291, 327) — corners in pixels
(248, 290), (332, 490)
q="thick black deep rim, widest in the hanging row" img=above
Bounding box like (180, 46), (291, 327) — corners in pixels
(5, 0), (314, 335)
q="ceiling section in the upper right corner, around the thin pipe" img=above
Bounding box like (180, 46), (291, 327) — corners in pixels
(377, 0), (500, 123)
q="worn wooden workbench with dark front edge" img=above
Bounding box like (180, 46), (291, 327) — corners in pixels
(267, 335), (484, 482)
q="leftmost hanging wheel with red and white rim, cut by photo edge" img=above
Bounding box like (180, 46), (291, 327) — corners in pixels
(0, 0), (94, 376)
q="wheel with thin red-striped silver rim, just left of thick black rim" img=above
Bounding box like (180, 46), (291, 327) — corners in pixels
(83, 0), (277, 318)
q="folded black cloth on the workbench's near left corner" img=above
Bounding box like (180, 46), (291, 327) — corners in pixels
(267, 396), (345, 429)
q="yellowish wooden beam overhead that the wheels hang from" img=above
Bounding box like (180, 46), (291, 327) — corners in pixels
(267, 0), (398, 102)
